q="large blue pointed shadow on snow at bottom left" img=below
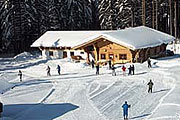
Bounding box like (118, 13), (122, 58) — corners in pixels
(3, 103), (79, 120)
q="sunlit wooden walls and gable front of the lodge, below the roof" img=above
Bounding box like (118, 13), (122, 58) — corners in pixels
(75, 36), (166, 64)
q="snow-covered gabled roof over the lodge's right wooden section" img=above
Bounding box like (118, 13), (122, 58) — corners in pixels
(74, 26), (175, 50)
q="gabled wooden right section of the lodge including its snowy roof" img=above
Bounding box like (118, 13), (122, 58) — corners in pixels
(73, 26), (175, 63)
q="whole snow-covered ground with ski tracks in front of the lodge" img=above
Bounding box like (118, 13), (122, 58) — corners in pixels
(0, 53), (180, 120)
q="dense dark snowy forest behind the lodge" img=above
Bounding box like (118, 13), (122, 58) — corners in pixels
(0, 0), (180, 54)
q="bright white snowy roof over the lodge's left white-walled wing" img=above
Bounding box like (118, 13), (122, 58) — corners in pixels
(31, 31), (112, 47)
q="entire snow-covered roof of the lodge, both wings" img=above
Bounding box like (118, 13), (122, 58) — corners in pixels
(31, 26), (175, 50)
